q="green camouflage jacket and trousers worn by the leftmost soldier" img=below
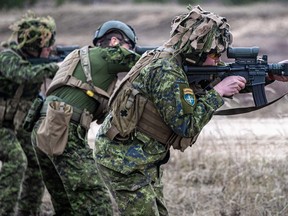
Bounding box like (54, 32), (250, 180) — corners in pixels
(0, 46), (58, 214)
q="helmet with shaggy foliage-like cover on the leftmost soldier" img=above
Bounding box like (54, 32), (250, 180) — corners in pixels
(10, 11), (56, 51)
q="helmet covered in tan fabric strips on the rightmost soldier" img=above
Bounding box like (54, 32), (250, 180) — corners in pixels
(165, 5), (232, 63)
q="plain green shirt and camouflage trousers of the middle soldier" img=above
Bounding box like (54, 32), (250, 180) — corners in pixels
(32, 46), (139, 215)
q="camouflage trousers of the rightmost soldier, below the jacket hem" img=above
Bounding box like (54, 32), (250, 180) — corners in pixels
(97, 164), (169, 216)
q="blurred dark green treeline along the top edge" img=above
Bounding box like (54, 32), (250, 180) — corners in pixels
(0, 0), (288, 10)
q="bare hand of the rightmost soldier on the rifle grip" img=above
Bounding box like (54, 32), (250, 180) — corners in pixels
(214, 76), (246, 97)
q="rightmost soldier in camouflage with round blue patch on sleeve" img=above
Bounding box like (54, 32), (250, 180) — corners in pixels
(95, 6), (246, 215)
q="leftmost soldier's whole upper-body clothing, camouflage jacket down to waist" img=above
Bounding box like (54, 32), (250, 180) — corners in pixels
(0, 42), (58, 128)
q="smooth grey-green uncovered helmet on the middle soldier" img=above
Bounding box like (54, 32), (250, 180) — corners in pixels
(93, 20), (137, 48)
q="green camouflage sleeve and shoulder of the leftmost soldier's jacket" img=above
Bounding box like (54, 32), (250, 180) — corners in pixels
(0, 44), (58, 101)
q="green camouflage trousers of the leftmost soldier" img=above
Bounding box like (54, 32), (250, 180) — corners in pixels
(0, 125), (44, 215)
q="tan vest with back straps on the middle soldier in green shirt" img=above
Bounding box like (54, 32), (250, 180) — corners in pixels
(46, 46), (117, 119)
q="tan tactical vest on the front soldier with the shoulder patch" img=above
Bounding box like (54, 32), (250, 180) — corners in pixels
(106, 48), (197, 151)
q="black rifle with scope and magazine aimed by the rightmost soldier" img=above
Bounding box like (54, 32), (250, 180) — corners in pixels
(135, 47), (288, 107)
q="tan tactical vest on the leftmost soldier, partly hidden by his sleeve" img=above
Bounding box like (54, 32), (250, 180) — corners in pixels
(0, 49), (32, 131)
